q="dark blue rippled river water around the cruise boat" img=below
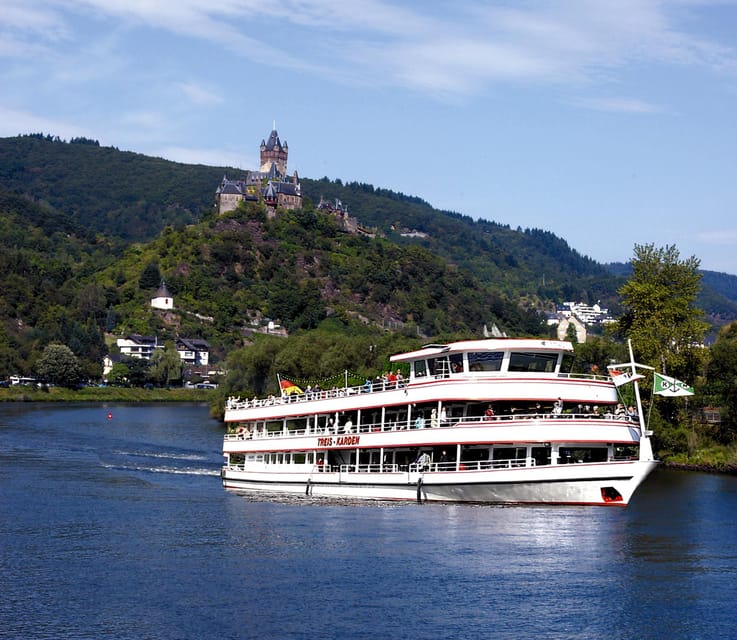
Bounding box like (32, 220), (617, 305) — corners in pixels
(0, 404), (737, 640)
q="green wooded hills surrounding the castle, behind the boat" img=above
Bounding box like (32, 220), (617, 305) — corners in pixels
(0, 135), (737, 376)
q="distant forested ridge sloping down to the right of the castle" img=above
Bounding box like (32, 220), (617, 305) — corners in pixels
(302, 178), (616, 303)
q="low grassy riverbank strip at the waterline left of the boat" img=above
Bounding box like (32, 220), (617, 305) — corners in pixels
(0, 385), (218, 404)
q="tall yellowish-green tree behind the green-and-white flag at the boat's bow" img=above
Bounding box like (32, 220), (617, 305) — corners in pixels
(618, 244), (708, 380)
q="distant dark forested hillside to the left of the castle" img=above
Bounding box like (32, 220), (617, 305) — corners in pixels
(0, 135), (230, 240)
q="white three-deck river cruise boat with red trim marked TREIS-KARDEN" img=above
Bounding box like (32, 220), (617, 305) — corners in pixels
(221, 338), (656, 506)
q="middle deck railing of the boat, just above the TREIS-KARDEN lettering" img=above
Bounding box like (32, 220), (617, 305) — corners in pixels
(225, 412), (639, 440)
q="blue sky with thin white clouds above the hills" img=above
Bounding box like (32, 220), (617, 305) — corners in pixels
(0, 0), (737, 274)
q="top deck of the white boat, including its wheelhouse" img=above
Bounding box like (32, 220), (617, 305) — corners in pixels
(225, 339), (616, 422)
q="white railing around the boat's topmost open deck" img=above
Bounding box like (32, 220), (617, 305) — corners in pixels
(225, 372), (611, 411)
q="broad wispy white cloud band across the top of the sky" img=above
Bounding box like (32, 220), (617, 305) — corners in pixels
(5, 0), (737, 99)
